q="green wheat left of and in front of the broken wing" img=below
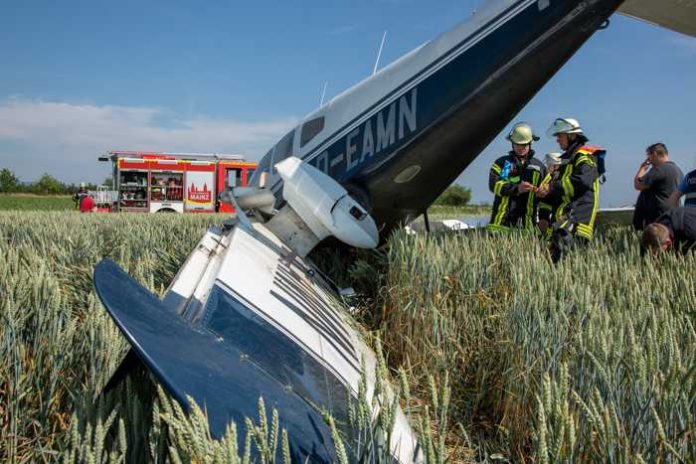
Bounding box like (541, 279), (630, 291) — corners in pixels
(0, 212), (448, 464)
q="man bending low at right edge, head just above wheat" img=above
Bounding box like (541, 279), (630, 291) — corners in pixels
(640, 208), (696, 254)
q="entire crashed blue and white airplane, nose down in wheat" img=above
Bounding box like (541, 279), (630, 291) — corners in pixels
(94, 0), (696, 463)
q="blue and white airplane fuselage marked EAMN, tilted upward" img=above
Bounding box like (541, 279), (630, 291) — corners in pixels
(252, 0), (622, 230)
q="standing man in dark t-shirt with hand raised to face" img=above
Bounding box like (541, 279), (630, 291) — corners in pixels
(633, 143), (684, 230)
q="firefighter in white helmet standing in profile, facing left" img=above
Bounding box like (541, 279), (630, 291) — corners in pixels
(537, 118), (606, 263)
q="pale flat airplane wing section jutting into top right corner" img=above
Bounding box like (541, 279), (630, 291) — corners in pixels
(619, 0), (696, 37)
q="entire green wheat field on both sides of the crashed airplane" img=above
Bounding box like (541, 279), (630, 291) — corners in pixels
(0, 212), (696, 463)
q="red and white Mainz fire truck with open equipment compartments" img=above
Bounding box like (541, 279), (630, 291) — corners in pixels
(95, 151), (256, 213)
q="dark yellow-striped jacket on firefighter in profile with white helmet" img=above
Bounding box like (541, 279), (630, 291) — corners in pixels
(550, 145), (605, 240)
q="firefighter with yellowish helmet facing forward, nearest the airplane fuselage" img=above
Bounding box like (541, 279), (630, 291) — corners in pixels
(488, 123), (546, 231)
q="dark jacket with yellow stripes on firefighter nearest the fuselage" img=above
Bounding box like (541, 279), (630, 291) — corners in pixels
(488, 151), (546, 230)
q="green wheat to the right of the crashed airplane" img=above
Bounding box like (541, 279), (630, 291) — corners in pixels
(334, 228), (696, 462)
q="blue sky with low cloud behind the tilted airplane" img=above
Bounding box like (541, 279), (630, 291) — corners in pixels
(0, 0), (696, 206)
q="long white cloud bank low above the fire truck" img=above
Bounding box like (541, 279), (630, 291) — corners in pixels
(0, 98), (297, 182)
